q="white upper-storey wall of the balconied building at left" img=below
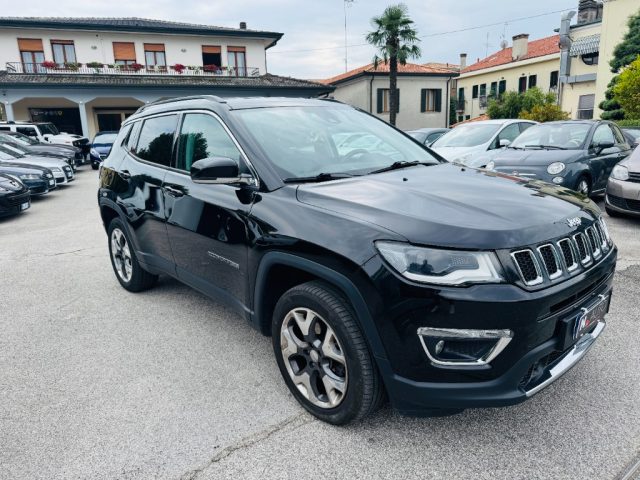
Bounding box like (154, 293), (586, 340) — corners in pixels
(0, 28), (271, 74)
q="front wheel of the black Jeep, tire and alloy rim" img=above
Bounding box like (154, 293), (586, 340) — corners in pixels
(271, 281), (384, 425)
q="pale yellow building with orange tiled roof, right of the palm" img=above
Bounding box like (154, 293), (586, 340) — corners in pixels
(456, 34), (560, 121)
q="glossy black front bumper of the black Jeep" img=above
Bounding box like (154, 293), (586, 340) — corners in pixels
(360, 248), (616, 416)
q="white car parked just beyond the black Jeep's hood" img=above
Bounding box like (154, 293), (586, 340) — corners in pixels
(431, 120), (537, 167)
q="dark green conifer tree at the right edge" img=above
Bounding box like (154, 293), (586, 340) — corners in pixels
(598, 11), (640, 120)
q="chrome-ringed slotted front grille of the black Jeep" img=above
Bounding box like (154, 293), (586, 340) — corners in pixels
(511, 218), (612, 286)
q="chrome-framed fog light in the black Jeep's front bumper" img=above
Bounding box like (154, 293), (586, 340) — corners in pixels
(418, 327), (513, 367)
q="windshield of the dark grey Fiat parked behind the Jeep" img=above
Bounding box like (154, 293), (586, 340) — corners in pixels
(509, 123), (591, 150)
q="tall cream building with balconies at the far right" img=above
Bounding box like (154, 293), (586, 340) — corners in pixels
(559, 0), (640, 119)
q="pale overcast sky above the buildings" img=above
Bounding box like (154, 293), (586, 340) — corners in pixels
(0, 0), (578, 78)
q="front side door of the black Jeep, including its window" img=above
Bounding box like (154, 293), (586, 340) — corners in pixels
(164, 112), (252, 309)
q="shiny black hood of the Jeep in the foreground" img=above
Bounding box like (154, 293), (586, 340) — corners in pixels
(297, 164), (599, 249)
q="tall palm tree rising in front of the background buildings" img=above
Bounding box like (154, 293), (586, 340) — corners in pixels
(367, 3), (421, 125)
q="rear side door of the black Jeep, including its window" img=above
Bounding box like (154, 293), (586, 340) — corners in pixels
(115, 114), (178, 274)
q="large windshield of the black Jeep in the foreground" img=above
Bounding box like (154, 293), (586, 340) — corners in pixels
(233, 105), (439, 179)
